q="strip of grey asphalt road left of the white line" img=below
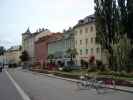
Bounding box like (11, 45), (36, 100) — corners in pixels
(0, 71), (23, 100)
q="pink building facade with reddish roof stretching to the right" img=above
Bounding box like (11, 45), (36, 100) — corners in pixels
(35, 33), (60, 69)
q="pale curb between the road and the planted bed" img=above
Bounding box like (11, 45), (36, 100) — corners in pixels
(23, 70), (133, 93)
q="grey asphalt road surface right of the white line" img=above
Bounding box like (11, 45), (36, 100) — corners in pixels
(8, 69), (133, 100)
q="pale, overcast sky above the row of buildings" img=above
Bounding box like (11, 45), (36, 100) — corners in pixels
(0, 0), (94, 48)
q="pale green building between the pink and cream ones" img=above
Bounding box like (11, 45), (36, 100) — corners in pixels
(48, 28), (74, 66)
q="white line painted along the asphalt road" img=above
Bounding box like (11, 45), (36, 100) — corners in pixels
(5, 71), (31, 100)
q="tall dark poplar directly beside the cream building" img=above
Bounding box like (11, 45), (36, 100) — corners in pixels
(95, 0), (118, 67)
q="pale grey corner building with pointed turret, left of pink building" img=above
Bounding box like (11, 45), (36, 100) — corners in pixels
(22, 28), (49, 64)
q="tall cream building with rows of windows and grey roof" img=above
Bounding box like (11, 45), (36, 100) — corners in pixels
(74, 15), (103, 64)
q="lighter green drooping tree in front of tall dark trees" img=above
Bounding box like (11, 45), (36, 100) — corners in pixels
(113, 35), (133, 71)
